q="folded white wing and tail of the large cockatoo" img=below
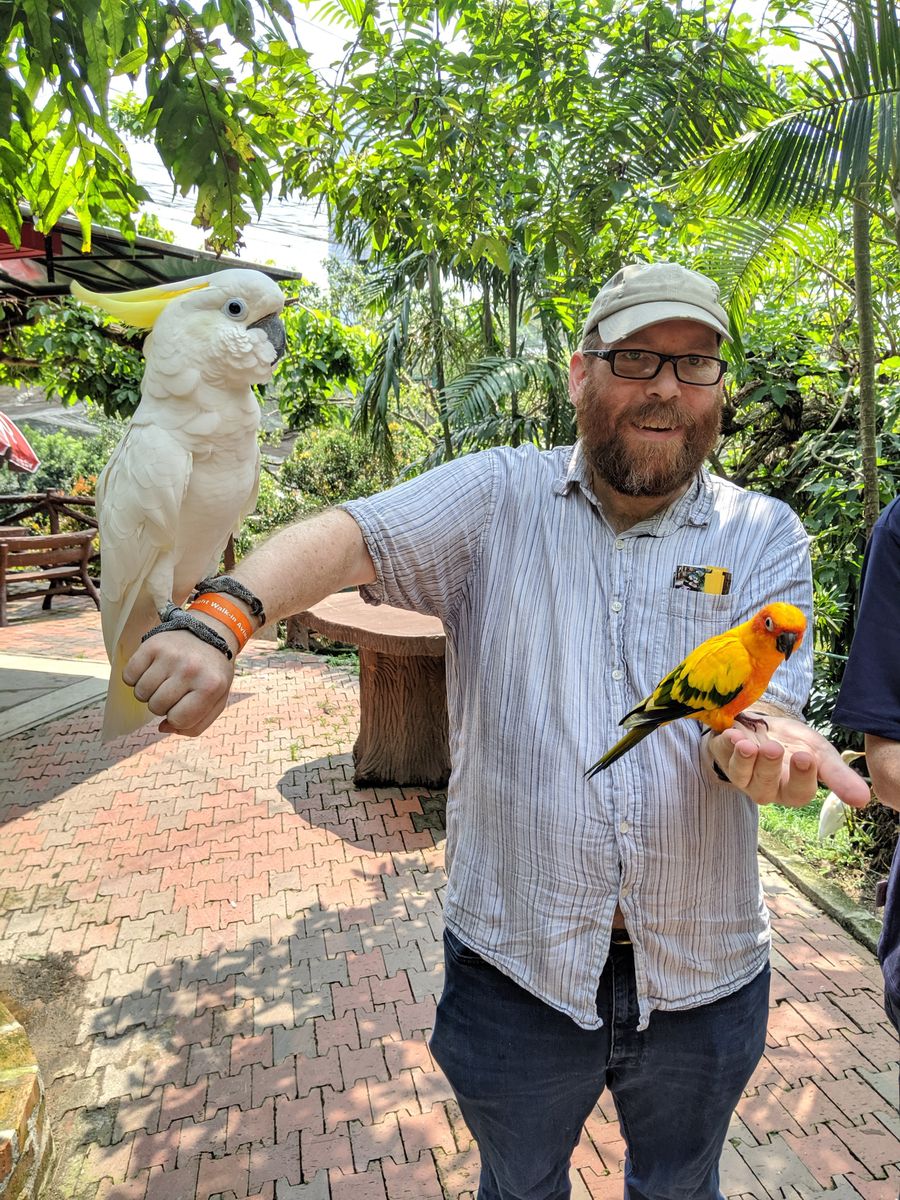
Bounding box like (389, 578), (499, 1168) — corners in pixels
(97, 425), (192, 740)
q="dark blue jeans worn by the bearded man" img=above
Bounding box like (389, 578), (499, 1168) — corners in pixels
(431, 930), (769, 1200)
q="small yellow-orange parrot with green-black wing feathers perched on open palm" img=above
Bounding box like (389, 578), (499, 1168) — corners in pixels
(587, 602), (806, 778)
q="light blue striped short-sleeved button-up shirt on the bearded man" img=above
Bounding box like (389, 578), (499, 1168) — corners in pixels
(346, 445), (812, 1028)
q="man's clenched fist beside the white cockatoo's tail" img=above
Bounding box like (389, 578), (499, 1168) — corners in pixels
(122, 630), (236, 738)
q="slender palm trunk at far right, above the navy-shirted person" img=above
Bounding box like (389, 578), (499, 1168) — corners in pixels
(853, 184), (881, 540)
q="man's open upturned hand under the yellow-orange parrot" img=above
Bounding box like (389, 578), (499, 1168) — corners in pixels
(703, 712), (870, 809)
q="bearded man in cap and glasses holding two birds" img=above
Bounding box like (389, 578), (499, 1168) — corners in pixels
(125, 264), (868, 1200)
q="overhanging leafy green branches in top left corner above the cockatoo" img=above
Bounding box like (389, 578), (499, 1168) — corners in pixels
(0, 0), (316, 247)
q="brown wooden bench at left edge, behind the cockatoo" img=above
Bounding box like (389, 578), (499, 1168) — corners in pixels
(0, 529), (100, 626)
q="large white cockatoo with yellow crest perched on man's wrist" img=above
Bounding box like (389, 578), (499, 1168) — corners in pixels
(72, 269), (284, 740)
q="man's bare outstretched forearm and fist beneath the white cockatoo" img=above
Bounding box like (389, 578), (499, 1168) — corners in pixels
(122, 509), (376, 737)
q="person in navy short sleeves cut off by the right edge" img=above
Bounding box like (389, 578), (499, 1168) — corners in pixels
(832, 497), (900, 1032)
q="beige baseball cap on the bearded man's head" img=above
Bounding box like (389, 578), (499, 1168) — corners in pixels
(582, 263), (731, 343)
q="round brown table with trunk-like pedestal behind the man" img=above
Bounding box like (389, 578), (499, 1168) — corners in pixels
(292, 592), (450, 787)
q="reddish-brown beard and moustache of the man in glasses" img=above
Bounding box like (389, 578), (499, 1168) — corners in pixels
(577, 386), (722, 497)
